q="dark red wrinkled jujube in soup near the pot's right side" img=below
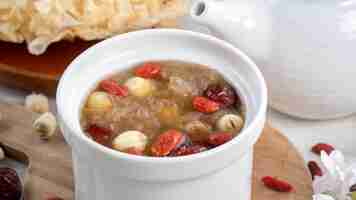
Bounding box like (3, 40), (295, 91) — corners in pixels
(204, 84), (237, 107)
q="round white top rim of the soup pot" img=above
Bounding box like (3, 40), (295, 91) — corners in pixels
(56, 29), (267, 164)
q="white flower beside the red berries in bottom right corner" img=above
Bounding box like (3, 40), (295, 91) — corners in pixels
(313, 150), (356, 200)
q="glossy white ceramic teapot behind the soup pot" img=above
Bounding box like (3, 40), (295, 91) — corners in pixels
(191, 0), (356, 119)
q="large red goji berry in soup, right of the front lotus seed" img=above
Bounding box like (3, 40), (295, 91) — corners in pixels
(151, 129), (184, 156)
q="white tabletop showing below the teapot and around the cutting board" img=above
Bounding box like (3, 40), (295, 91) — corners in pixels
(0, 83), (356, 160)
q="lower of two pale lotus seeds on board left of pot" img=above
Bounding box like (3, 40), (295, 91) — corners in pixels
(33, 112), (57, 140)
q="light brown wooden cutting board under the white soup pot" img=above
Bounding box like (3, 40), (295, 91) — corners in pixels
(0, 102), (312, 200)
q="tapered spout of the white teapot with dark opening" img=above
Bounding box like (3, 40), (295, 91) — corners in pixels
(190, 0), (271, 62)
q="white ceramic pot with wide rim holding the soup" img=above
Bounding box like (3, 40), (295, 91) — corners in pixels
(57, 30), (267, 200)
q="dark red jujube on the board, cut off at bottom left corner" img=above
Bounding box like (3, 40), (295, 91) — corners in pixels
(0, 167), (22, 200)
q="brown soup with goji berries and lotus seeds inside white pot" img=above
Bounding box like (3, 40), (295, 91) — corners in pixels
(81, 61), (244, 157)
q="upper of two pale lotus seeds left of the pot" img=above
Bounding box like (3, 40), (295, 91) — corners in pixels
(25, 93), (49, 114)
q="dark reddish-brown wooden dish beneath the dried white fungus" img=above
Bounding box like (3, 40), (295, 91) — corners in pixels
(0, 40), (97, 95)
